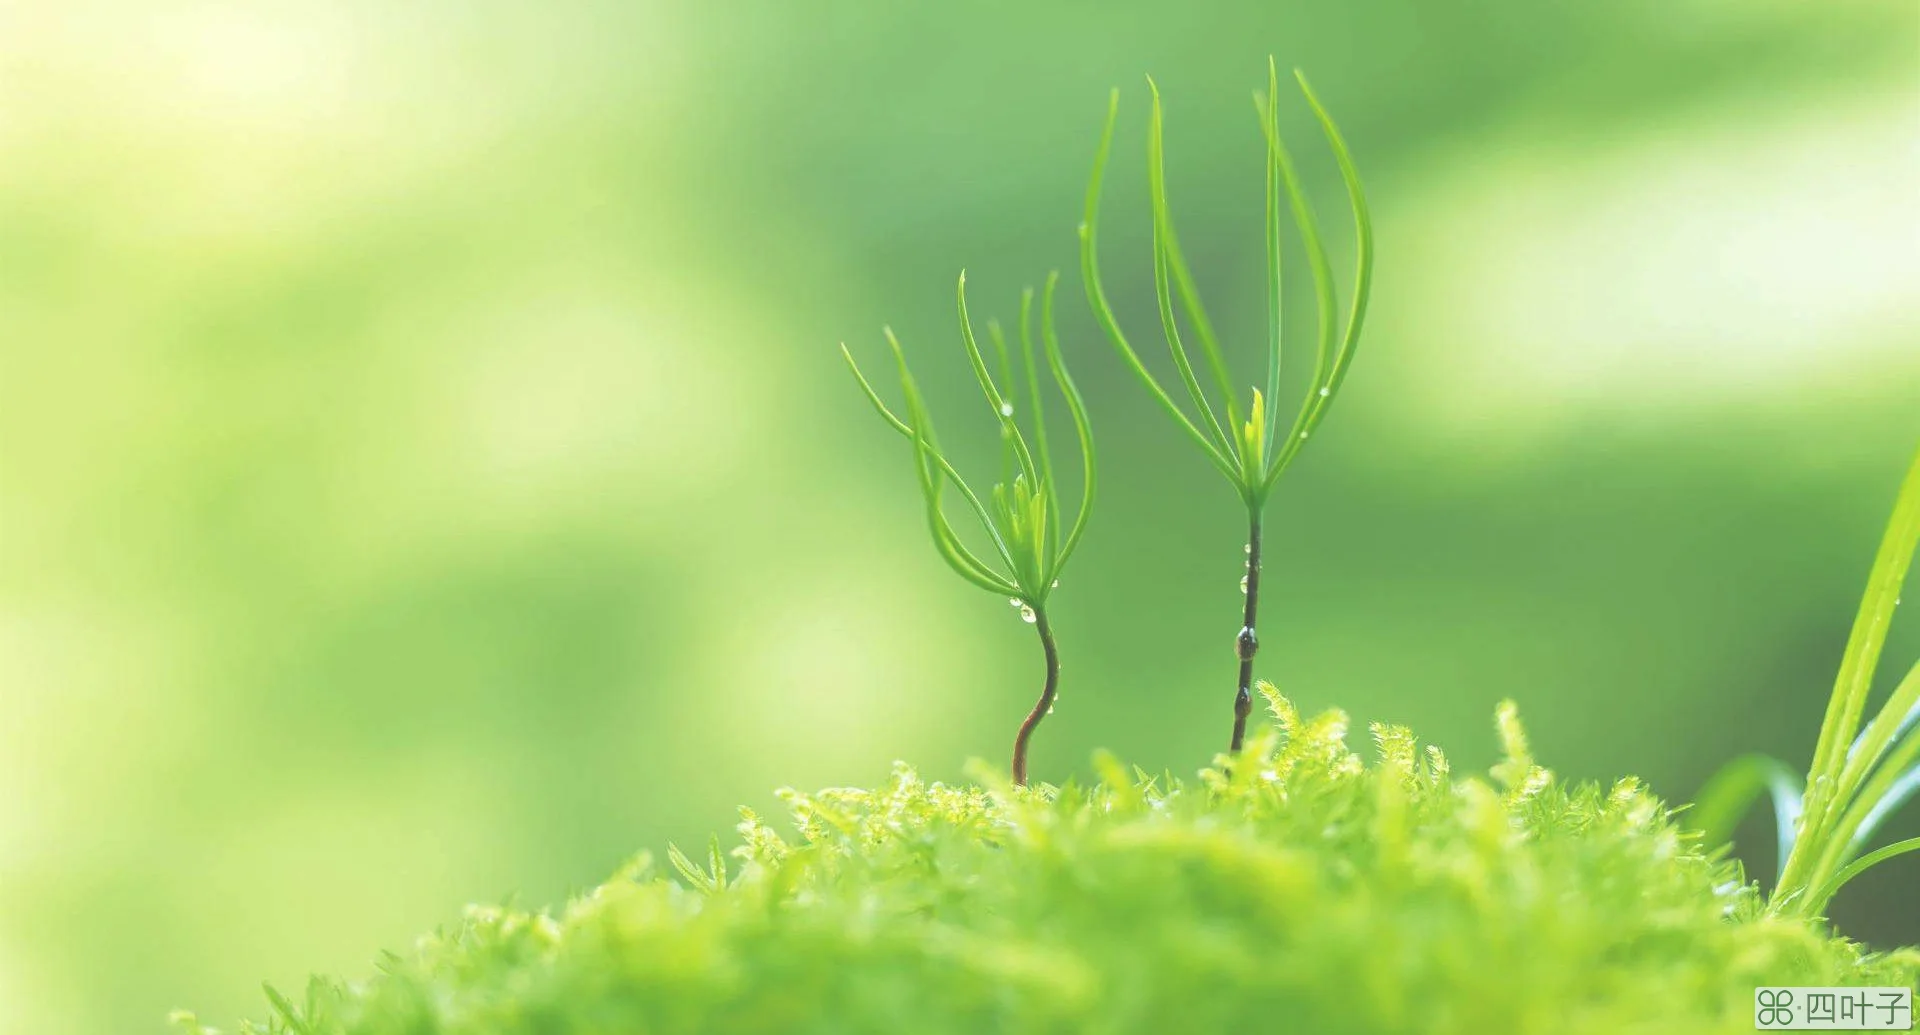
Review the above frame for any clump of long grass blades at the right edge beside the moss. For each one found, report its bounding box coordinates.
[1692,441,1920,918]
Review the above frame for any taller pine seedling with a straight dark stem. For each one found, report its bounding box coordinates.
[1081,58,1373,753]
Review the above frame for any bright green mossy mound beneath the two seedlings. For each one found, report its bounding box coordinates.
[177,687,1920,1035]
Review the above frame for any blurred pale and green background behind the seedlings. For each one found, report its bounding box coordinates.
[0,0,1920,1033]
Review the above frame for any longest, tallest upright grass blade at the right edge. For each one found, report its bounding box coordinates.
[1807,443,1920,867]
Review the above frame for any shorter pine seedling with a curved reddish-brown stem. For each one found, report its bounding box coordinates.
[841,271,1094,785]
